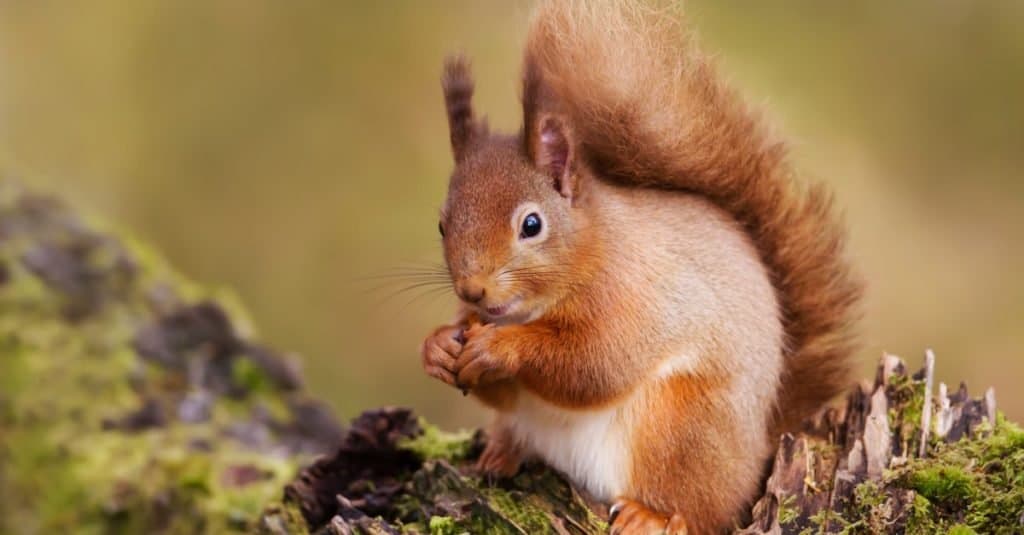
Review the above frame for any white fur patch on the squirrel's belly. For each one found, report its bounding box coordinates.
[502,392,630,501]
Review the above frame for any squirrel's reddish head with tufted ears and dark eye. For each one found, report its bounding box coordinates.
[438,57,589,323]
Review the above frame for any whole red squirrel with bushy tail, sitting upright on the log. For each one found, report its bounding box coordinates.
[421,0,862,534]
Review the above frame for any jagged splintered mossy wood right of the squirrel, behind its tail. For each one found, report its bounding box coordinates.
[743,352,1024,534]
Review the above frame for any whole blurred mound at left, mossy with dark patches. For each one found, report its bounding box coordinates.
[0,182,340,533]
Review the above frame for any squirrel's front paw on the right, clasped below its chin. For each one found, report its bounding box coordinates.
[454,324,519,390]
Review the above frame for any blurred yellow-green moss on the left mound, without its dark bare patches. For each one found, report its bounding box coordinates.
[0,189,315,534]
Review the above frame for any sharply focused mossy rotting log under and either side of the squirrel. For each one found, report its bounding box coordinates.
[267,354,1024,535]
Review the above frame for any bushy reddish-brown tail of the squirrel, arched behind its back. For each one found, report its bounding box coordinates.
[522,0,862,433]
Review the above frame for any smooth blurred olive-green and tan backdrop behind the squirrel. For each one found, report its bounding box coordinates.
[0,0,1024,426]
